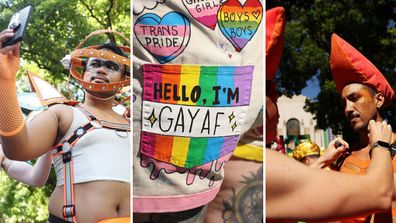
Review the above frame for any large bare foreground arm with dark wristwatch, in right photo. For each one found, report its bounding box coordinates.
[266,121,393,220]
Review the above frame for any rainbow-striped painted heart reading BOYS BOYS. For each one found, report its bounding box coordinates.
[217,0,263,52]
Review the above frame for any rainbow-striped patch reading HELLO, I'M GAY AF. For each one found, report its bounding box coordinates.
[140,64,253,168]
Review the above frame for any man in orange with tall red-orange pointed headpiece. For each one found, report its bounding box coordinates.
[330,34,396,222]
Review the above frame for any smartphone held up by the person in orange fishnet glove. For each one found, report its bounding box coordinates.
[2,5,32,47]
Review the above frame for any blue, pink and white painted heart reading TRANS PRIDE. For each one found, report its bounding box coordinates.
[134,12,191,64]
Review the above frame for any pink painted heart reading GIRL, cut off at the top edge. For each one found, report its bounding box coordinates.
[183,0,221,30]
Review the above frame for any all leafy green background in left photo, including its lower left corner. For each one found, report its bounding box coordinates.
[0,0,130,223]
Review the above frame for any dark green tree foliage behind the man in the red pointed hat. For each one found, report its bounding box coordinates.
[267,0,396,143]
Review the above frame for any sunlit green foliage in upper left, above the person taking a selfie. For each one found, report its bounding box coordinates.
[0,0,130,88]
